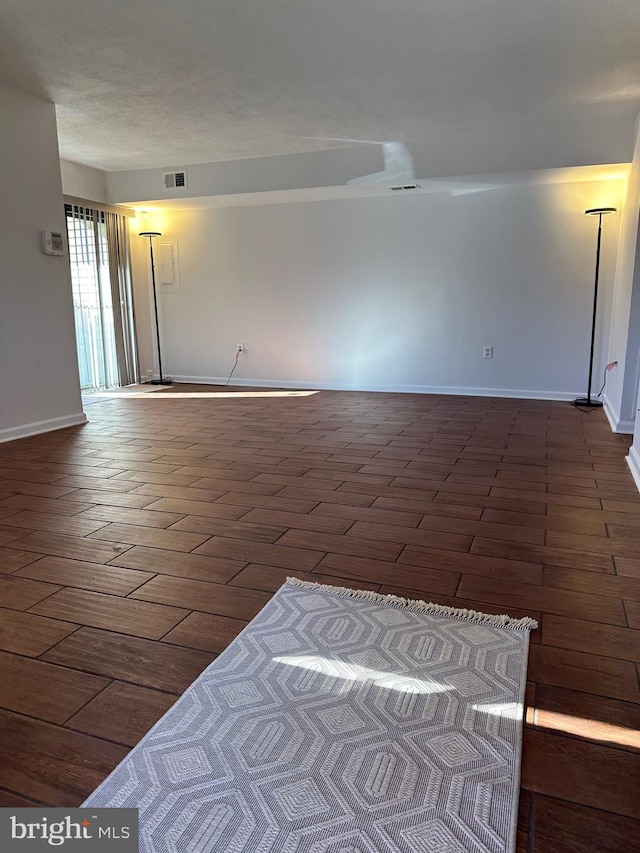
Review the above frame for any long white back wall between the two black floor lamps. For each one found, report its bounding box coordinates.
[133,173,624,399]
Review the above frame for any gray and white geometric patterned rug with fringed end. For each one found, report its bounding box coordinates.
[84,579,537,853]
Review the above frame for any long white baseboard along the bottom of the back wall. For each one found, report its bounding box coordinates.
[171,373,580,402]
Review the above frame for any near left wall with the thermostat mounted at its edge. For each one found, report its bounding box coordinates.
[0,85,85,441]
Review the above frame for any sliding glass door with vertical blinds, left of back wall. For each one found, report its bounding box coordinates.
[65,204,138,391]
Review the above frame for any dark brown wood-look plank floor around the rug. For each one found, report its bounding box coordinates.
[0,389,640,853]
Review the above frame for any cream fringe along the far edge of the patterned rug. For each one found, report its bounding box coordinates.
[287,577,538,631]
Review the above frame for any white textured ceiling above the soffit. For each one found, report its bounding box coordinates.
[0,0,640,170]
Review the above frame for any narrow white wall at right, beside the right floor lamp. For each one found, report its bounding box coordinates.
[605,115,640,433]
